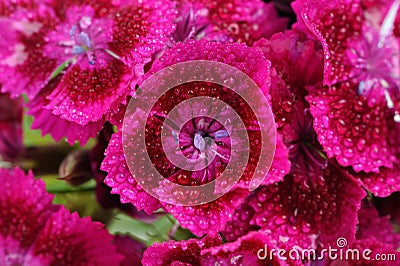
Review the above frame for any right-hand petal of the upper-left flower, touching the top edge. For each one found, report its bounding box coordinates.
[110,0,176,71]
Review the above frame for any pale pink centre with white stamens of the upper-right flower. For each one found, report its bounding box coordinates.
[347,0,400,122]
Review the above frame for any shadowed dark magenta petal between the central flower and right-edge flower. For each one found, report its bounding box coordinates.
[254,31,323,139]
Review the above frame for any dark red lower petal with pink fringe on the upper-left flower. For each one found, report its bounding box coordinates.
[46,53,131,125]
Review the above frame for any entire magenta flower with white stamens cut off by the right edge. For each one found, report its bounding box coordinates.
[300,1,400,196]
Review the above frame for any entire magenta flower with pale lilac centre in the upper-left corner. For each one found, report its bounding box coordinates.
[0,0,175,143]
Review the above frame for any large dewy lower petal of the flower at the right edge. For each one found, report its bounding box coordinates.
[307,82,397,173]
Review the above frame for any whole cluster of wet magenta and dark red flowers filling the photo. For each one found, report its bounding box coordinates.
[0,0,400,265]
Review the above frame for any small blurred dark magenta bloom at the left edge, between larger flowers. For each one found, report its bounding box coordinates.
[0,94,24,162]
